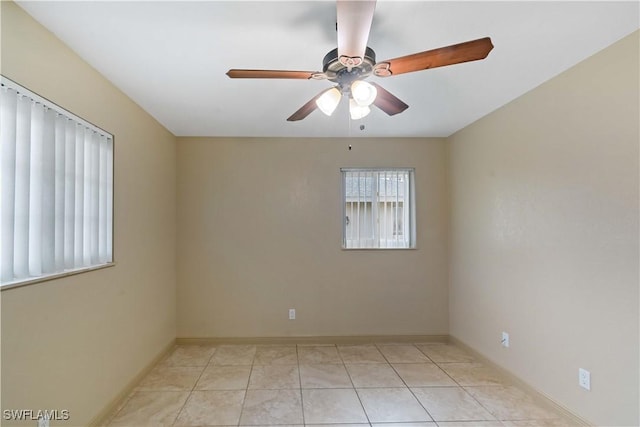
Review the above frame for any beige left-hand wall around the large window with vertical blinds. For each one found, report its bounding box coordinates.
[1,1,176,426]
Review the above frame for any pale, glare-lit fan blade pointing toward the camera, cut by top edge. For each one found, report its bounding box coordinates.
[336,0,376,68]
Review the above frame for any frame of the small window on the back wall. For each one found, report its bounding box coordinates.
[340,167,418,251]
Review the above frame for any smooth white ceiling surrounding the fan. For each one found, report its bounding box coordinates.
[18,0,640,137]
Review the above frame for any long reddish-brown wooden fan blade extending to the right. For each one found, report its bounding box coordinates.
[373,37,493,77]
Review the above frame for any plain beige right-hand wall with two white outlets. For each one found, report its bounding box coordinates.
[449,32,640,426]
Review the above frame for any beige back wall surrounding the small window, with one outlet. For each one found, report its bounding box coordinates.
[172,138,448,338]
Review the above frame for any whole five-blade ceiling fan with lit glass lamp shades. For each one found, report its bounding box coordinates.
[227,0,493,121]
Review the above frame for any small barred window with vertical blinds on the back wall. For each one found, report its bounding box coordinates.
[342,169,415,249]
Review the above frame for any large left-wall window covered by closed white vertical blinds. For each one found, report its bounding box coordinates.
[0,77,113,287]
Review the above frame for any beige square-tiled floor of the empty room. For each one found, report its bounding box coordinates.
[108,343,570,427]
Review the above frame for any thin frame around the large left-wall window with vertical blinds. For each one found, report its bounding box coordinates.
[0,75,116,292]
